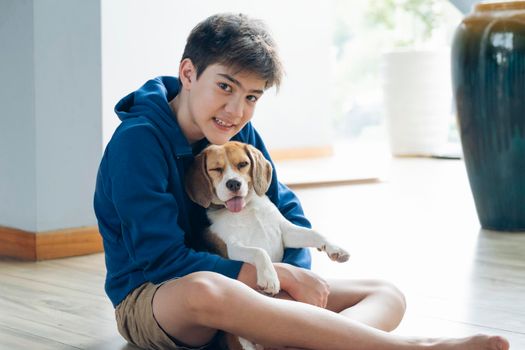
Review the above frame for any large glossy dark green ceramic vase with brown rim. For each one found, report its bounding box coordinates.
[452,1,525,231]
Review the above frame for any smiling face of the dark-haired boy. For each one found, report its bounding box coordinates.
[181,61,266,145]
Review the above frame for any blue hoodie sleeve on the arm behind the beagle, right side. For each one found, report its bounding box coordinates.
[236,123,312,269]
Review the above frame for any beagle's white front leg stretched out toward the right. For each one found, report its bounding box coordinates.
[280,217,350,262]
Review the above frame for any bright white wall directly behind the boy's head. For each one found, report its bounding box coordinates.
[102,0,332,149]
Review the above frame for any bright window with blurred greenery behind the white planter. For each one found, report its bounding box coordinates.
[332,0,462,157]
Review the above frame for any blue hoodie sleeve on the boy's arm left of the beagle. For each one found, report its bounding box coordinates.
[107,126,246,283]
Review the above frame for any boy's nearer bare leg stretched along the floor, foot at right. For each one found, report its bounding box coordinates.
[153,272,509,350]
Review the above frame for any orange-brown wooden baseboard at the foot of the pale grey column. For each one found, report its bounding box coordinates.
[0,226,104,261]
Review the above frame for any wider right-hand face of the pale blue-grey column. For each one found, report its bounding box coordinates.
[34,0,102,231]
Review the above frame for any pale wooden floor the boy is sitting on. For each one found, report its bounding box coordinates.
[0,159,525,350]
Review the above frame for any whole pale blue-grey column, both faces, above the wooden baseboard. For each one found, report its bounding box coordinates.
[0,0,102,232]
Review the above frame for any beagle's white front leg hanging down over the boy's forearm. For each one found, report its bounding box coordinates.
[227,242,281,295]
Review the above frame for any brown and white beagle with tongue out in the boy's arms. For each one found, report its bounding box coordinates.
[185,141,349,350]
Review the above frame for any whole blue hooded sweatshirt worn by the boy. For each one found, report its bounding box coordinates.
[94,77,311,306]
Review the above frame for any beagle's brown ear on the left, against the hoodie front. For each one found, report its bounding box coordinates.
[184,152,213,208]
